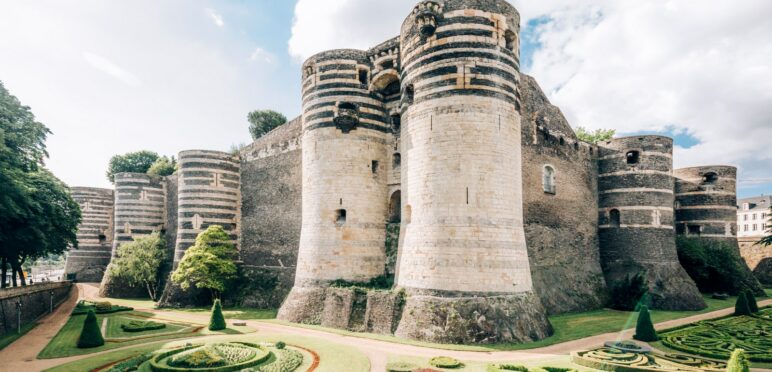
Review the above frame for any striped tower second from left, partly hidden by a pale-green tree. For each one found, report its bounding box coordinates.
[99,173,166,297]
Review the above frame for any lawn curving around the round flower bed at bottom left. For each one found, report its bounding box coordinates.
[46,333,370,372]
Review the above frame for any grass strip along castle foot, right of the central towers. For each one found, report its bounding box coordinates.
[269,290,772,351]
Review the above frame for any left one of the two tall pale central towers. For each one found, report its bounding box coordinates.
[278,50,395,322]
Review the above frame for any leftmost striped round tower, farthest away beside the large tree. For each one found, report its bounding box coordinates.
[64,187,114,283]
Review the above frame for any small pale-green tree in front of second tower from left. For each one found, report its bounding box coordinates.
[109,232,169,301]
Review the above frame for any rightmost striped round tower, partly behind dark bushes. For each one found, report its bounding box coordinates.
[673,165,764,295]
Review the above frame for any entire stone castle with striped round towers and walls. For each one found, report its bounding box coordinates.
[67,0,764,342]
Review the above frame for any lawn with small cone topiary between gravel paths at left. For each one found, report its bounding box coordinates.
[38,311,254,359]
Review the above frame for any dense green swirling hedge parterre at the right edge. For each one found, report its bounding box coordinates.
[661,308,772,362]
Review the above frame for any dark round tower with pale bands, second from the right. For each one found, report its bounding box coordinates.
[598,136,705,310]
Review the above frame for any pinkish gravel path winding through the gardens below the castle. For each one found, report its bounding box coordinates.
[0,284,772,372]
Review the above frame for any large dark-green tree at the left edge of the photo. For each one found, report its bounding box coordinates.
[0,83,81,287]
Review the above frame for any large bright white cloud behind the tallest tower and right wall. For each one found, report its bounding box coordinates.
[289,0,772,190]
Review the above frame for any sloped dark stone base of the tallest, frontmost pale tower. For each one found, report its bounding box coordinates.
[395,292,552,344]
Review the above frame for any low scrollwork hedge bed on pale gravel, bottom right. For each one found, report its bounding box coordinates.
[571,347,726,371]
